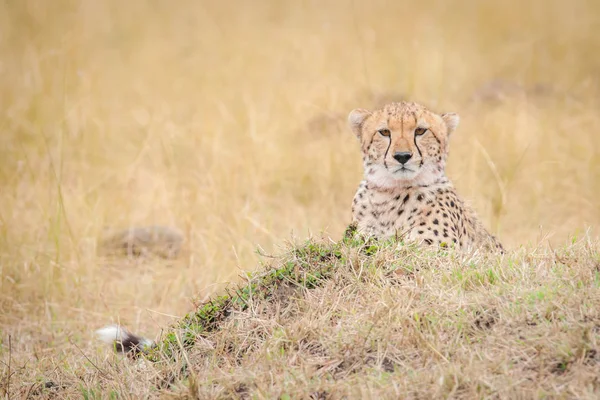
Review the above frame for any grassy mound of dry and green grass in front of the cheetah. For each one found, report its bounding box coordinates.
[105,239,600,399]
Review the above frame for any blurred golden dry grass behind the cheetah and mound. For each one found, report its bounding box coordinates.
[0,0,600,376]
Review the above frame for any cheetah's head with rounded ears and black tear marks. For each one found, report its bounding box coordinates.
[348,102,459,187]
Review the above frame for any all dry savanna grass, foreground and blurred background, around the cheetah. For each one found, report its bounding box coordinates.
[0,0,600,398]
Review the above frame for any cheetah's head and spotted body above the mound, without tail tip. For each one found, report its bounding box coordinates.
[348,102,503,252]
